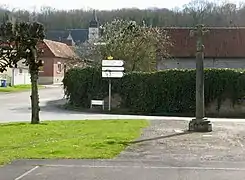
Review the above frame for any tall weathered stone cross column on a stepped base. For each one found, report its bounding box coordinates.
[189,24,212,132]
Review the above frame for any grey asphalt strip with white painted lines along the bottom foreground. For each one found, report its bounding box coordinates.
[0,160,245,180]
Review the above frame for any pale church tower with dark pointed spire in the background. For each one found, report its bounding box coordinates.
[88,10,99,42]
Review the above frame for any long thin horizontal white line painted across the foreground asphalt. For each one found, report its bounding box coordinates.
[44,164,245,171]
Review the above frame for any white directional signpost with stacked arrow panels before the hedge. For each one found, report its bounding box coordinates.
[102,57,124,111]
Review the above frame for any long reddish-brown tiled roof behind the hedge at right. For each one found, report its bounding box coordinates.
[164,27,245,58]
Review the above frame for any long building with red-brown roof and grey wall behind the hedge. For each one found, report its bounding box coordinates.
[157,27,245,70]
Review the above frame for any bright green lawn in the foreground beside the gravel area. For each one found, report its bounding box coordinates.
[0,120,148,165]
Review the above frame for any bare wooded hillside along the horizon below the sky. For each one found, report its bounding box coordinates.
[0,0,245,30]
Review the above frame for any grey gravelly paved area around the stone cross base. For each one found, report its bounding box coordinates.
[118,120,245,162]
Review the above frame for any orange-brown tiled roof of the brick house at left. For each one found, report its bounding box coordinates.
[44,39,77,59]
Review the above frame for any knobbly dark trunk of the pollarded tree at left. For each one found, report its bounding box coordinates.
[30,70,40,124]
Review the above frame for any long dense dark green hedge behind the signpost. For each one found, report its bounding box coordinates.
[63,67,245,114]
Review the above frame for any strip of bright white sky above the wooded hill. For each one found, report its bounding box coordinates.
[0,0,245,10]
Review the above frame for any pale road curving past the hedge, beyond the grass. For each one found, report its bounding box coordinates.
[0,86,245,123]
